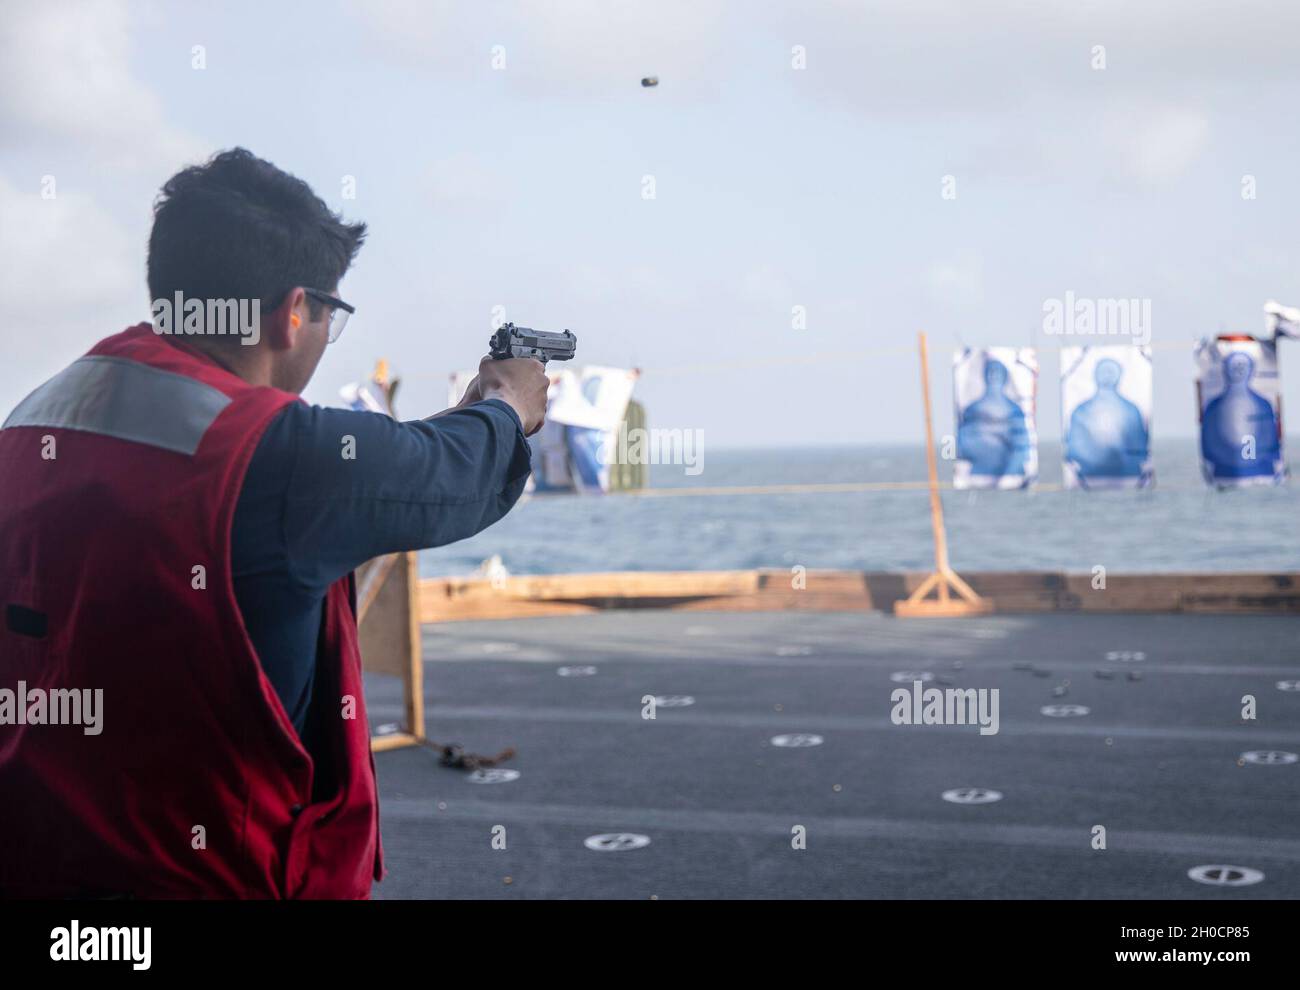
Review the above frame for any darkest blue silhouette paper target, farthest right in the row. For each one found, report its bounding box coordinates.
[1196,338,1287,489]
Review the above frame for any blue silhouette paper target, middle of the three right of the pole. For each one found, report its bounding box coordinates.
[1061,347,1154,490]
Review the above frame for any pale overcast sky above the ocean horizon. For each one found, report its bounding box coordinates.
[0,0,1300,447]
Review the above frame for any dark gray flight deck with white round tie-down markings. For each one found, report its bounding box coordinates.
[368,611,1300,899]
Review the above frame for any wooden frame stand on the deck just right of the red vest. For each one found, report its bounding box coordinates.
[356,552,424,752]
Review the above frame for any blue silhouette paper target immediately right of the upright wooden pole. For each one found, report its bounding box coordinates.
[953,347,1039,489]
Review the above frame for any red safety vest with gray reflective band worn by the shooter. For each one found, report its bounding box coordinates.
[0,324,384,898]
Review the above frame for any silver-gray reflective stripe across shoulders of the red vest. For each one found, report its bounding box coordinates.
[0,356,230,456]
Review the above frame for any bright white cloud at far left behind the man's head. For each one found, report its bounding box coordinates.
[0,0,200,414]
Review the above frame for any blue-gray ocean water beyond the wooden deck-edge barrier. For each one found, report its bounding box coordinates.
[420,438,1300,577]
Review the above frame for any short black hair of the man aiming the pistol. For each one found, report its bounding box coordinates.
[148,148,365,320]
